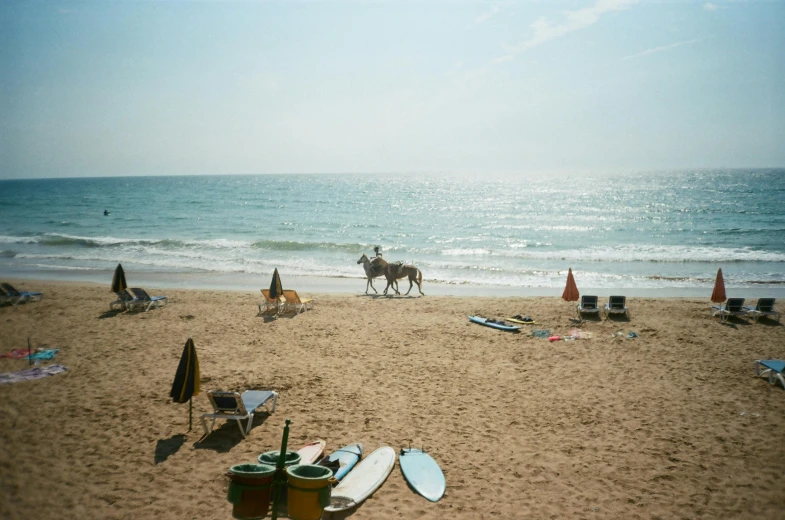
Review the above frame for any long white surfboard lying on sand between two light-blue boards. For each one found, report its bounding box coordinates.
[324,446,395,513]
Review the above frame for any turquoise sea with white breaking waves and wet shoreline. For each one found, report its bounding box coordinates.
[0,169,785,297]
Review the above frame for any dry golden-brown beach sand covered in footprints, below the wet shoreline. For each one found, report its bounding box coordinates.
[0,281,785,520]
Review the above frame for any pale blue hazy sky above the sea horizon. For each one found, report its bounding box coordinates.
[0,0,785,179]
